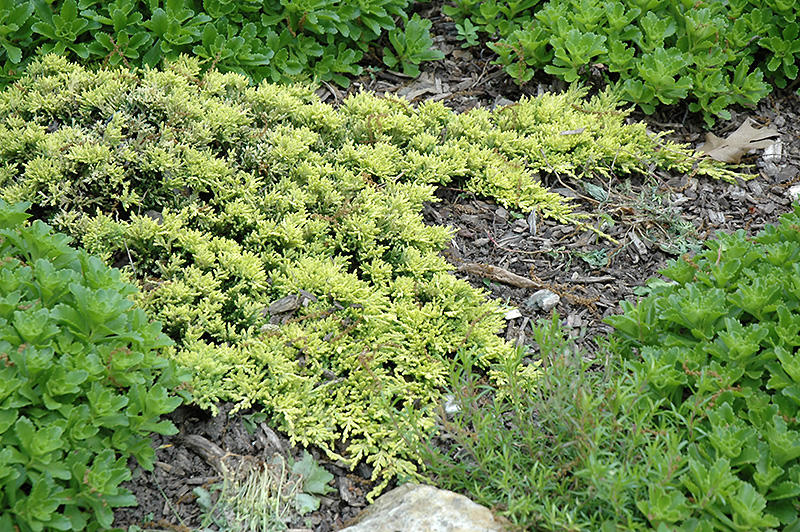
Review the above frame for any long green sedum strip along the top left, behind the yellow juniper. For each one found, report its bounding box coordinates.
[0,0,442,87]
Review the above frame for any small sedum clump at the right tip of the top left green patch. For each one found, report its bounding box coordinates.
[383,13,444,77]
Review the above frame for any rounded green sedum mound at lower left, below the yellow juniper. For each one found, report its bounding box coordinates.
[0,200,187,532]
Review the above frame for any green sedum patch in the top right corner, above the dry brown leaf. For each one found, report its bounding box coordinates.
[444,0,800,126]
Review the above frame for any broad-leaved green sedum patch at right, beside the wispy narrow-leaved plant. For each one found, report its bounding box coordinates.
[609,206,800,530]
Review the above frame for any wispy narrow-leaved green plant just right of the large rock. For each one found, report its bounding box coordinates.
[404,316,682,531]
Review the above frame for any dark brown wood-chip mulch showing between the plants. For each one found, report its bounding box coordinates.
[115,2,800,532]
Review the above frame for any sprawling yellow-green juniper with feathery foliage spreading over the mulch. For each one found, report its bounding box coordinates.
[0,56,736,494]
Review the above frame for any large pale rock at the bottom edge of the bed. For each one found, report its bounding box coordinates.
[340,484,508,532]
